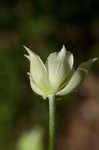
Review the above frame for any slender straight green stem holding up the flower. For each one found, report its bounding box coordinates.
[49,95,55,150]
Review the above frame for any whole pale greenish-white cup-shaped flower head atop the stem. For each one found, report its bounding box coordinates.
[24,45,97,99]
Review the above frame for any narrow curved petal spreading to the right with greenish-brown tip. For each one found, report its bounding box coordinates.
[56,58,97,95]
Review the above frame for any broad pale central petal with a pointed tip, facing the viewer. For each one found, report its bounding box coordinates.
[46,45,73,89]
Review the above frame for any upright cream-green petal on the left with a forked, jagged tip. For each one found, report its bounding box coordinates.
[24,46,49,90]
